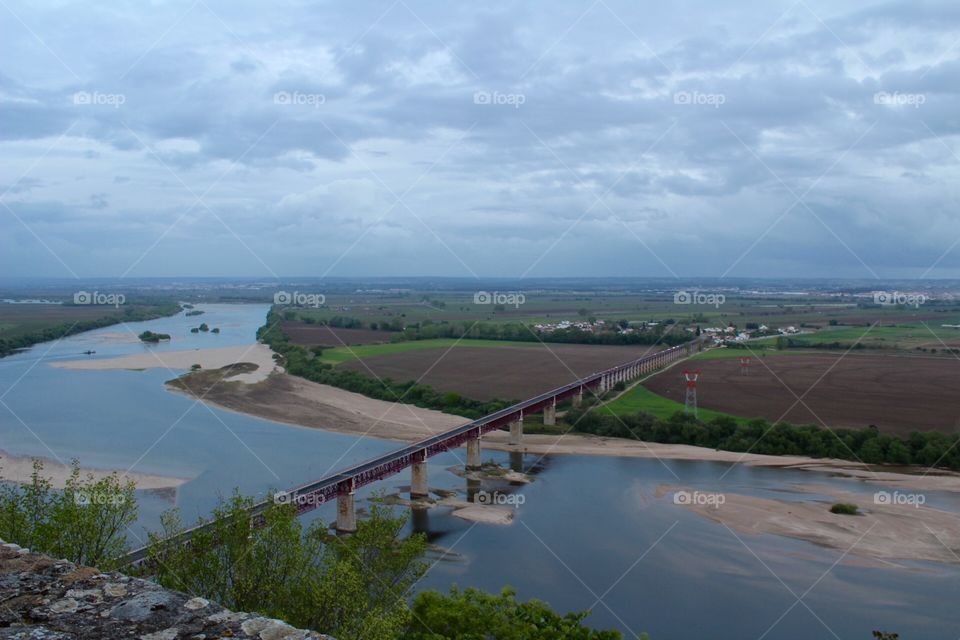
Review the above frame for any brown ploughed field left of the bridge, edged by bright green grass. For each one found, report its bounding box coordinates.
[339,343,663,400]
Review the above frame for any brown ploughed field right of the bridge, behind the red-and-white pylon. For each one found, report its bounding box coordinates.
[645,353,960,435]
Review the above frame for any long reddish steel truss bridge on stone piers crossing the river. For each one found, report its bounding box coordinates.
[120,341,697,566]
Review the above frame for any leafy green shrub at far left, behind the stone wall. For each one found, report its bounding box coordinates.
[0,460,137,570]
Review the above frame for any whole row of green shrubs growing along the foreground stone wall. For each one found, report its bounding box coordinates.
[0,462,620,640]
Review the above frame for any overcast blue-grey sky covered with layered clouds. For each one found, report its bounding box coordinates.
[0,0,960,278]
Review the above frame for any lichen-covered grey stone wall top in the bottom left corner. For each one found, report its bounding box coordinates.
[0,541,333,640]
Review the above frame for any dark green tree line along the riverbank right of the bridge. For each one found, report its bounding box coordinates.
[565,403,960,470]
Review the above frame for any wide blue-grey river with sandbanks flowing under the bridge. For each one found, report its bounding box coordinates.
[0,305,960,640]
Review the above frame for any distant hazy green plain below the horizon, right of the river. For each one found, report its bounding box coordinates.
[280,283,960,337]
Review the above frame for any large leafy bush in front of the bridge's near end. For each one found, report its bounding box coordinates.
[150,494,426,640]
